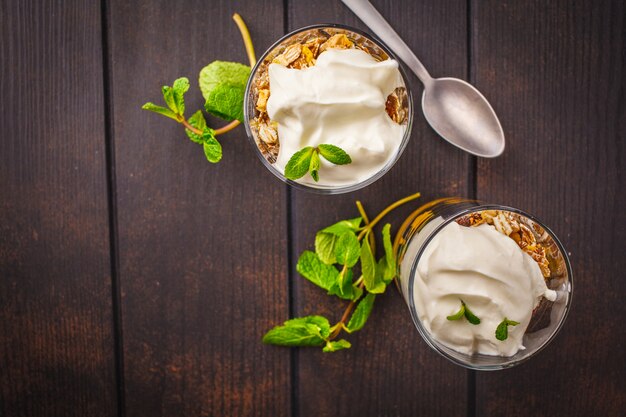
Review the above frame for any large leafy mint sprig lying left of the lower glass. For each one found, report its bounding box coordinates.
[263,193,420,352]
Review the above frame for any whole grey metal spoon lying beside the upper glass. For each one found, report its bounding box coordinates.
[341,0,504,158]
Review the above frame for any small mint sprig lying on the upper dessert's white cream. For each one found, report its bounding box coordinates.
[285,144,352,182]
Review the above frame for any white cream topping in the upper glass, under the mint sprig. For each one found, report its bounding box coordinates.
[267,49,406,186]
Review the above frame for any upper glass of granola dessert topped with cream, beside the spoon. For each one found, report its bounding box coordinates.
[244,24,413,194]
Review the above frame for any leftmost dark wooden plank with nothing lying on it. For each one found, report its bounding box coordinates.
[0,1,117,417]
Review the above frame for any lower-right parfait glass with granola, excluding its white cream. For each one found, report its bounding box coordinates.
[394,198,573,370]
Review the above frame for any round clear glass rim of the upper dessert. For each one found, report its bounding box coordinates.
[243,23,414,195]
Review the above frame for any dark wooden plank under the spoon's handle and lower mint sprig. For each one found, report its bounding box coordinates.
[288,0,470,416]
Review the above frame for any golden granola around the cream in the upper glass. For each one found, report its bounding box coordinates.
[250,28,408,163]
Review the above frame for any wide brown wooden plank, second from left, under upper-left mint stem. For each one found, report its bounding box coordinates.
[111,1,290,416]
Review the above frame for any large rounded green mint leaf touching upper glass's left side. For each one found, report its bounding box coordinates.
[198,61,250,123]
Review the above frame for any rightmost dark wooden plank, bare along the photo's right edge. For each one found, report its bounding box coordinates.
[473,1,626,416]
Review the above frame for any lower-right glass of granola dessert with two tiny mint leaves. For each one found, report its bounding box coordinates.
[395,198,572,370]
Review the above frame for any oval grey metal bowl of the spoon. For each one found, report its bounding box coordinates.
[422,78,504,158]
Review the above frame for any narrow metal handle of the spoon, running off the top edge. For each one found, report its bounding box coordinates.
[341,0,432,84]
